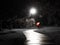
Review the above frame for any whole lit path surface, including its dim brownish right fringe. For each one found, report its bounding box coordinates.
[24,29,54,45]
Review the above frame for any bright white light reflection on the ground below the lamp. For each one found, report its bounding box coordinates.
[24,29,46,45]
